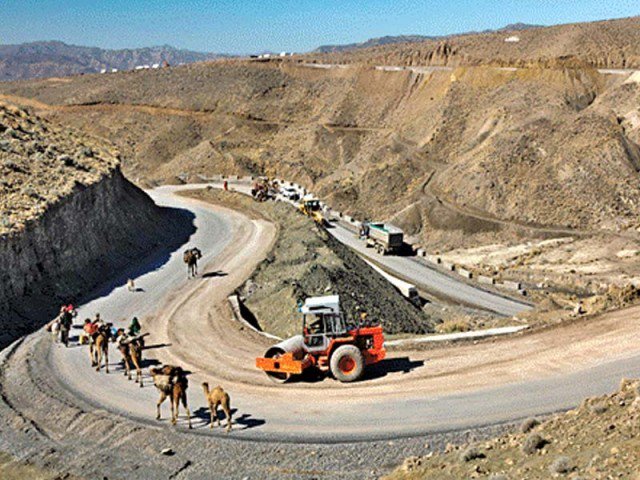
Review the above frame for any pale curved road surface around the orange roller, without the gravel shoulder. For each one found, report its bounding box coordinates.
[1,187,640,443]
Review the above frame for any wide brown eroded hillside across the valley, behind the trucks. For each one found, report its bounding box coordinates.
[0,57,640,251]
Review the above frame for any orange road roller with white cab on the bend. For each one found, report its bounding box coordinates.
[256,295,386,383]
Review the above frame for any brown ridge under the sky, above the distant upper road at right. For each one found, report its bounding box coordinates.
[307,17,640,68]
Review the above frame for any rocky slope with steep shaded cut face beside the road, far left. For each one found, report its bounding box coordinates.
[0,106,191,348]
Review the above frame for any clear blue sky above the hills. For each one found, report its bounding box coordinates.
[0,0,640,54]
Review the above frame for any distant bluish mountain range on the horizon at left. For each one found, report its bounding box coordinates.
[0,41,230,81]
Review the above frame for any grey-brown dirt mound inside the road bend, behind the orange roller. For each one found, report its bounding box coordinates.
[184,189,434,337]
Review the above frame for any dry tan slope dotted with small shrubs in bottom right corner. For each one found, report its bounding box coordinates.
[385,381,640,480]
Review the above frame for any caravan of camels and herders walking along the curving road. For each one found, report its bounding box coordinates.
[47,248,232,433]
